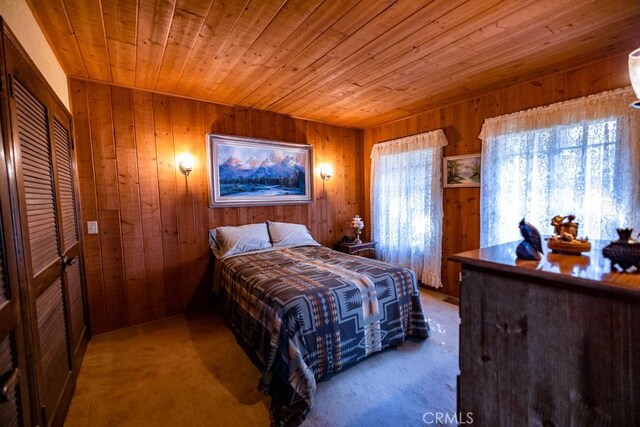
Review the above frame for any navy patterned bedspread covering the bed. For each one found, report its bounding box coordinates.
[220,246,429,425]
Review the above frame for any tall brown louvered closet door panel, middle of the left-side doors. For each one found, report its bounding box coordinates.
[12,79,71,424]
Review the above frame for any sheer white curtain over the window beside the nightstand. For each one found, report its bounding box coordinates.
[371,130,447,287]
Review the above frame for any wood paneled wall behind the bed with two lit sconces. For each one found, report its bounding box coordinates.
[70,79,364,333]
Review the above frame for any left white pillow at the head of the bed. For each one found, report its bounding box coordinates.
[209,222,271,258]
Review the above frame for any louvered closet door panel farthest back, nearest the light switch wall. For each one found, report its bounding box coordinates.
[53,118,86,354]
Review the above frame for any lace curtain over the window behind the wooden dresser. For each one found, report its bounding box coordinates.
[480,88,640,247]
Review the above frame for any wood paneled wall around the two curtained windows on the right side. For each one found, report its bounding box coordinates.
[364,55,630,296]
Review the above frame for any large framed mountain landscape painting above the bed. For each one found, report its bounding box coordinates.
[207,134,313,207]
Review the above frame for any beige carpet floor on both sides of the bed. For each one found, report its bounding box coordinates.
[65,291,459,427]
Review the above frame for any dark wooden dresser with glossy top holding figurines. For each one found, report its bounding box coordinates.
[450,242,640,427]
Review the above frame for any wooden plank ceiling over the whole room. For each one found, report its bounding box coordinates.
[27,0,640,127]
